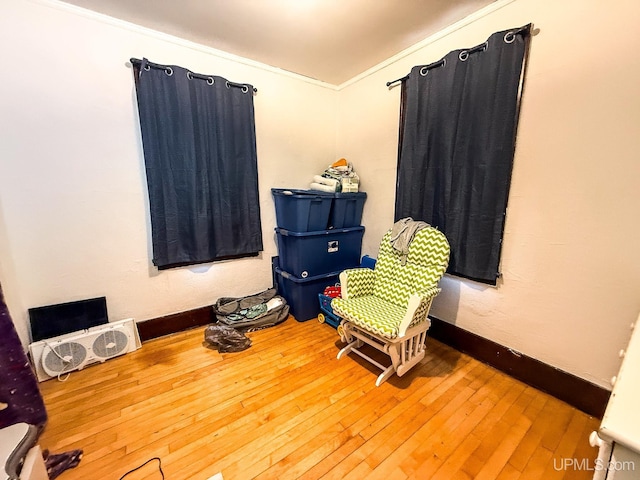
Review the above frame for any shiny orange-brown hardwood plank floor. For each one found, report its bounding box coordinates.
[40,318,599,480]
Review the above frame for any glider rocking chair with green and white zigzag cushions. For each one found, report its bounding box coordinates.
[331,226,449,386]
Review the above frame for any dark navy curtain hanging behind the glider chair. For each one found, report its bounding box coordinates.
[395,25,531,285]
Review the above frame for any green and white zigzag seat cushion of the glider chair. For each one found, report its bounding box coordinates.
[331,295,406,339]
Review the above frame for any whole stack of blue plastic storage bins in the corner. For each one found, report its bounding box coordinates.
[271,188,367,322]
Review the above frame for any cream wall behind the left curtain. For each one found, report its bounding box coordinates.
[0,0,337,343]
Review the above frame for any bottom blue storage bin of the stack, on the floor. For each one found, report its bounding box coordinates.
[274,267,340,322]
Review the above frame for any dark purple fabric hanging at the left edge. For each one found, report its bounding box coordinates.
[0,286,47,428]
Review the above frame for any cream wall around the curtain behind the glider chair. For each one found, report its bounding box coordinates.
[337,0,640,388]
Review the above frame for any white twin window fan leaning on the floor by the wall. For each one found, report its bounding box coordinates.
[29,318,141,382]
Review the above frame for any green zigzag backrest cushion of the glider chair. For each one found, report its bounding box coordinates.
[373,226,449,307]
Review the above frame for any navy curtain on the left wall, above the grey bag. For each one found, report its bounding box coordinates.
[131,59,262,268]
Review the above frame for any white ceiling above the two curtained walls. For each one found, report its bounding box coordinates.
[65,0,494,85]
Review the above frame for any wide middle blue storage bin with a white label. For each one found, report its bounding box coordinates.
[276,227,364,278]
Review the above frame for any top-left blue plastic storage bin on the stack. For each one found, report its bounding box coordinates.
[271,188,333,232]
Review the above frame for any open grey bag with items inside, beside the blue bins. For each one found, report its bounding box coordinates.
[213,288,289,332]
